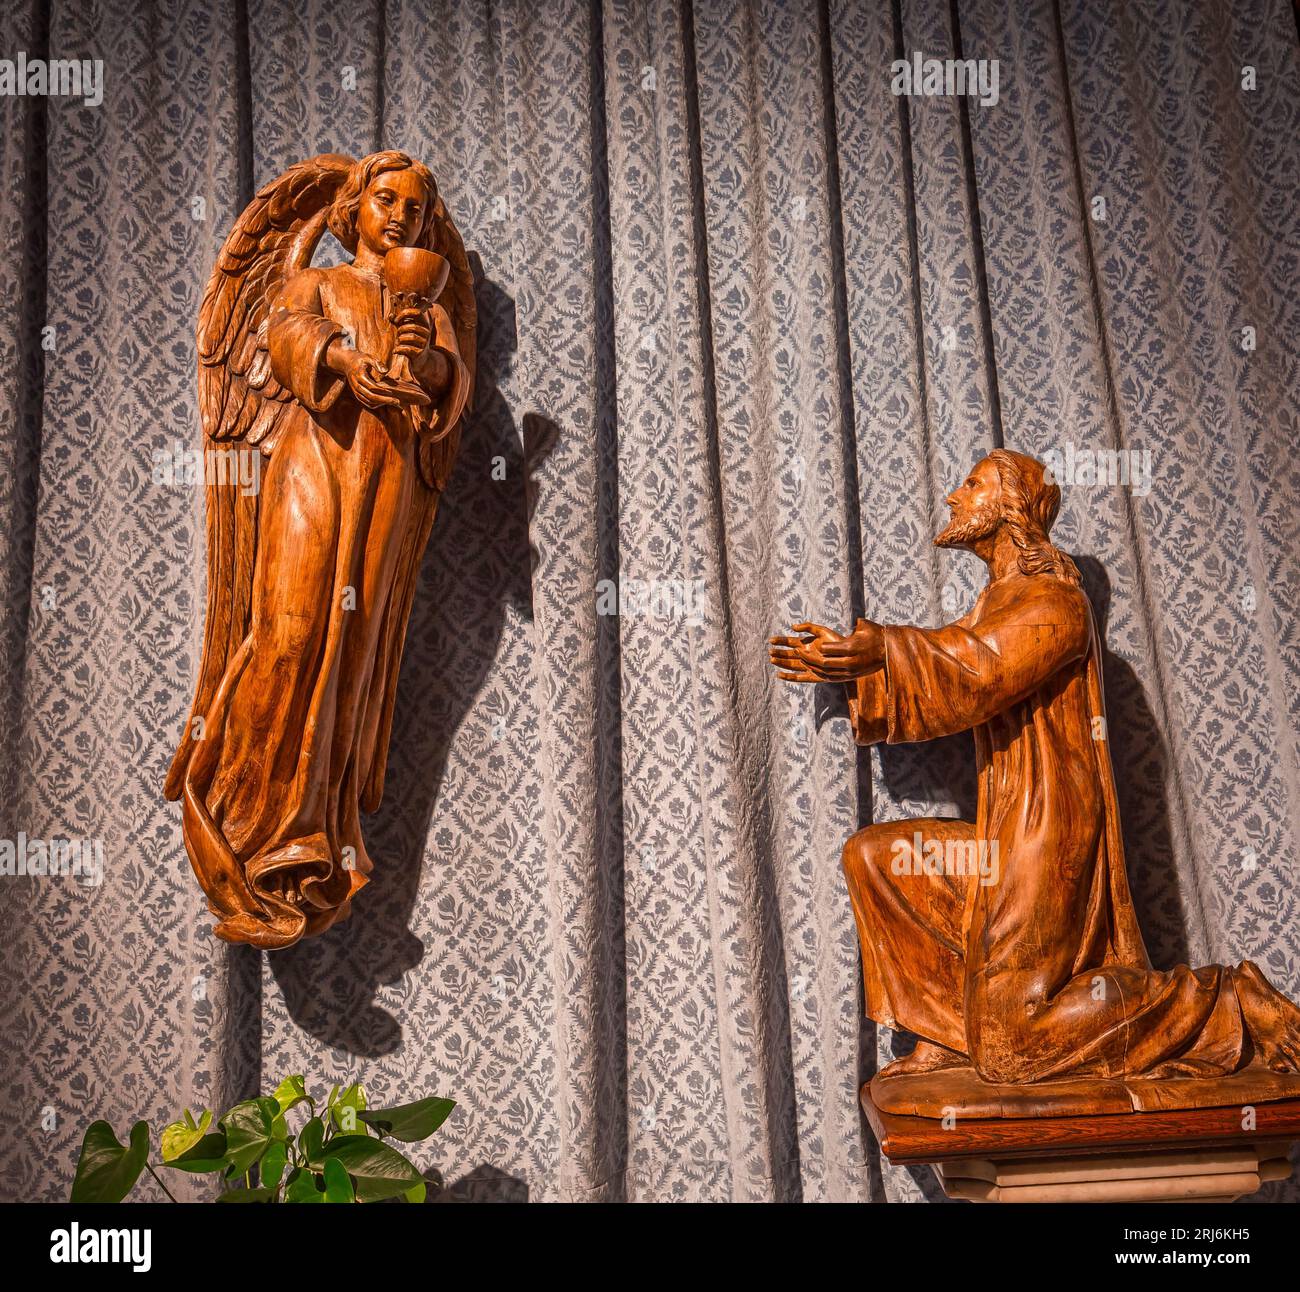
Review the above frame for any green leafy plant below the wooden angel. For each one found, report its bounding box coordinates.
[72,1076,456,1202]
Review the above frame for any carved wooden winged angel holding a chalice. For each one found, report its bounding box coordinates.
[165,152,476,949]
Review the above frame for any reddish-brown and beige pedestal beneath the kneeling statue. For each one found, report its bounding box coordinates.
[862,1084,1300,1202]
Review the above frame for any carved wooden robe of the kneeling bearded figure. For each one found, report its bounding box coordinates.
[844,573,1300,1083]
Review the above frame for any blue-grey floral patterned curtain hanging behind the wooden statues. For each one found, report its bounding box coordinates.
[0,0,1300,1200]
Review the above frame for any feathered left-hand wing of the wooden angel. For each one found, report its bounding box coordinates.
[164,153,353,798]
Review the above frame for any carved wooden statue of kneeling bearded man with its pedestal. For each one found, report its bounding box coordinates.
[770,450,1300,1198]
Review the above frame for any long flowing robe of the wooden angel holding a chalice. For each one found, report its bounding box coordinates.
[169,265,468,948]
